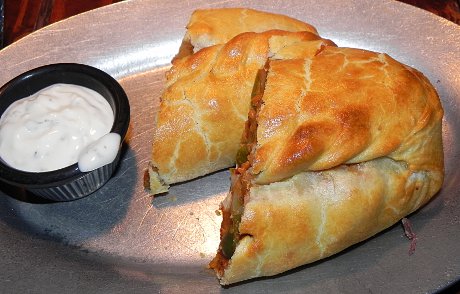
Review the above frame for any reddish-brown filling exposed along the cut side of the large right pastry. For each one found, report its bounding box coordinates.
[210,66,267,275]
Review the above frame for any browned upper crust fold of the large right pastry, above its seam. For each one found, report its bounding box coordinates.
[252,47,443,184]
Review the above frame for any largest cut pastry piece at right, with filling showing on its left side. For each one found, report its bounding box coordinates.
[210,47,444,285]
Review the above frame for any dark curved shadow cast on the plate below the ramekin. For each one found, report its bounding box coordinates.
[0,146,138,245]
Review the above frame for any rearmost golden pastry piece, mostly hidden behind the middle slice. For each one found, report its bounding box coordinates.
[177,8,318,57]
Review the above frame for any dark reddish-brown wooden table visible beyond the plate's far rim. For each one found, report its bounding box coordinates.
[0,0,460,47]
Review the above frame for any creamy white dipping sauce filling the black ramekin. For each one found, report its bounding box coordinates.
[0,84,119,172]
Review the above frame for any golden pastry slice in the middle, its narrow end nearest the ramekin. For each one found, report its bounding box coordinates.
[149,30,333,194]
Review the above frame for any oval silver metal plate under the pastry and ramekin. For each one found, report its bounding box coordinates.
[0,0,460,293]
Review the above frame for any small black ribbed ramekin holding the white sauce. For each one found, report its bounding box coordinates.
[0,63,130,201]
